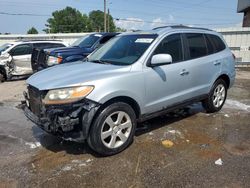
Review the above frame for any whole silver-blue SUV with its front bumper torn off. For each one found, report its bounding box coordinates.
[23,26,235,155]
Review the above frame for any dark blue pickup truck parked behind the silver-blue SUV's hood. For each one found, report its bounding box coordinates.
[32,33,118,72]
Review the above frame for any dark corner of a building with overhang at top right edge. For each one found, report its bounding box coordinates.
[237,0,250,27]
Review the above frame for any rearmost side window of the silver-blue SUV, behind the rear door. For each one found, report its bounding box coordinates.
[206,34,226,54]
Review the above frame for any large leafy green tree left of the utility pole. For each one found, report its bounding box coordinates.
[44,7,91,33]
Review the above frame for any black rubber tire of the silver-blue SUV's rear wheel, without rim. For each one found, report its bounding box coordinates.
[202,79,227,113]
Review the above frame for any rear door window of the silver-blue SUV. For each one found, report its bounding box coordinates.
[186,33,207,59]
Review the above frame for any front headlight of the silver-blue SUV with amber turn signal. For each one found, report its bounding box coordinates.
[43,86,94,105]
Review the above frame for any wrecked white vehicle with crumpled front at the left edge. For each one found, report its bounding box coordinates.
[0,40,65,81]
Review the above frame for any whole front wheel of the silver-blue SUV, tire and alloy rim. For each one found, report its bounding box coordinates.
[87,102,136,156]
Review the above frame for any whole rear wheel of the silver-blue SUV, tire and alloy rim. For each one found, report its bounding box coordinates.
[202,79,227,113]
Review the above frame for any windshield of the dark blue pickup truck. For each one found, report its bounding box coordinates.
[72,34,102,48]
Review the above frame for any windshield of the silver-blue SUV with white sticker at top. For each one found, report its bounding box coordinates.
[88,34,157,65]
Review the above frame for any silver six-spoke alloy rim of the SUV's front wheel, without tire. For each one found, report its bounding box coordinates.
[101,111,132,149]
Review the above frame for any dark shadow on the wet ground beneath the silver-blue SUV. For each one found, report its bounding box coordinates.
[32,103,204,157]
